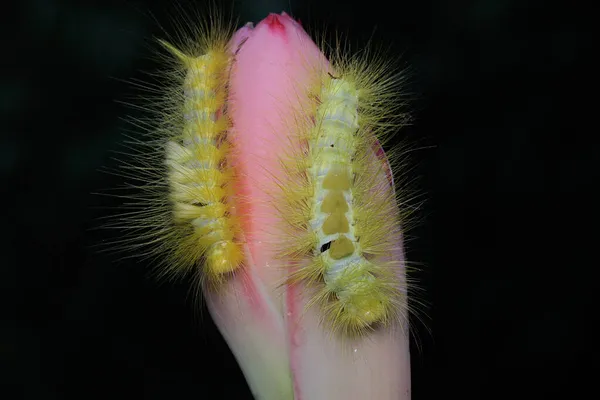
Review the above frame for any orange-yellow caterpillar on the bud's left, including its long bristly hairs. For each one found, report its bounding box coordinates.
[105,12,244,288]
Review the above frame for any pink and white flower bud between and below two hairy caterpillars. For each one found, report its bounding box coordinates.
[206,13,410,400]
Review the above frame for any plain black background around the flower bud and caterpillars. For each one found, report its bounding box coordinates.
[0,0,598,399]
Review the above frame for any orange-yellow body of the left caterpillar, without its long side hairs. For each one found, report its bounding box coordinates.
[162,42,243,280]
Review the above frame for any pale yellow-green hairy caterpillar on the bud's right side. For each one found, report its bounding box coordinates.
[277,41,418,337]
